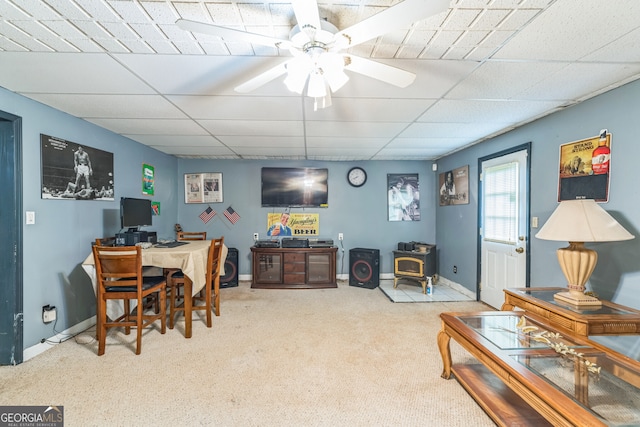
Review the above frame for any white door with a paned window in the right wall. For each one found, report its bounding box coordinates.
[480,150,529,309]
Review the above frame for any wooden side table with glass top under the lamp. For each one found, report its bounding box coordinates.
[501,288,640,336]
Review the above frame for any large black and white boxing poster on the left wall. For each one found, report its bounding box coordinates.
[40,134,114,200]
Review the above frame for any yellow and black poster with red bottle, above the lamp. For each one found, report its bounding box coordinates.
[558,129,611,202]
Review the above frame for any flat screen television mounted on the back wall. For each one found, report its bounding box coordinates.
[262,168,329,208]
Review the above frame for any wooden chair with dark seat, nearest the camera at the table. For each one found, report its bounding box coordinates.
[92,245,167,356]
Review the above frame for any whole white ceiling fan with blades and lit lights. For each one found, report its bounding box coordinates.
[176,0,450,108]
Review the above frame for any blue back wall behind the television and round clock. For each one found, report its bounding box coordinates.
[178,160,436,275]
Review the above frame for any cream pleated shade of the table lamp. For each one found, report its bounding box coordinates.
[536,199,635,242]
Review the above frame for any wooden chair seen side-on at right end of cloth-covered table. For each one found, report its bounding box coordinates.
[167,236,224,329]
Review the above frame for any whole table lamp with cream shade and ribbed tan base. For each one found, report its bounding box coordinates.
[536,199,635,306]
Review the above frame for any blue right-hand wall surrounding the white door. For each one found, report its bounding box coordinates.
[434,77,640,309]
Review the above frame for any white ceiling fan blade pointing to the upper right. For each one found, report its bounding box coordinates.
[335,0,451,49]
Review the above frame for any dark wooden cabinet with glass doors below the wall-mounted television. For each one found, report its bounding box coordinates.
[251,247,338,289]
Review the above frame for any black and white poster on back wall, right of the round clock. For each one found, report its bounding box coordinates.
[387,173,420,221]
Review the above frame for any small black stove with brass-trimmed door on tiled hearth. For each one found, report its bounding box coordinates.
[393,245,436,294]
